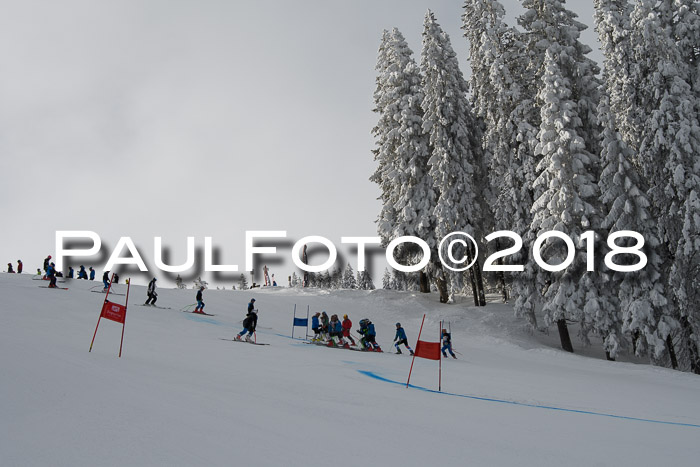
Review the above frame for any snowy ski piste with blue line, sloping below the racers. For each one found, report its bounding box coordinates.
[0,274,700,466]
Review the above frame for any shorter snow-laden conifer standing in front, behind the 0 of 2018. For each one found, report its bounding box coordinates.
[532,47,600,352]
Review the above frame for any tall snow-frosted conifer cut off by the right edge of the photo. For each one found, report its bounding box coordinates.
[629,0,700,373]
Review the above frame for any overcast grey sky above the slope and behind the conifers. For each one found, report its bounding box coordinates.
[0,0,598,284]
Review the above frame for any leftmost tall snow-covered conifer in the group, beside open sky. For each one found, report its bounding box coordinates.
[370,28,435,292]
